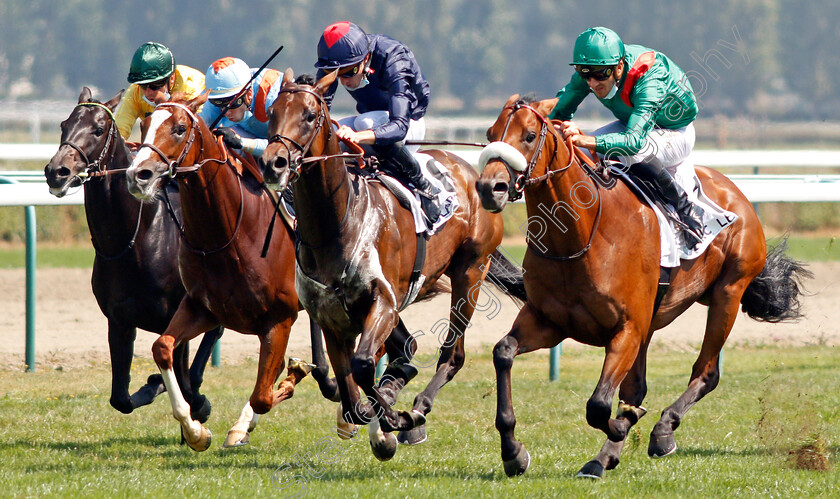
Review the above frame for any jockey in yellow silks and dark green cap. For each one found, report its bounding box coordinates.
[114,42,204,139]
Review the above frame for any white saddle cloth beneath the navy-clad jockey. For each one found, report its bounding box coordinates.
[380,153,459,236]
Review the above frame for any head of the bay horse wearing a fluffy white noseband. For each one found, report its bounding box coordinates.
[476,94,564,213]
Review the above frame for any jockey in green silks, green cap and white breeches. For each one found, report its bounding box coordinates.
[548,27,703,248]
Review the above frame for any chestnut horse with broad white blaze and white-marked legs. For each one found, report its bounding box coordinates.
[127,93,316,451]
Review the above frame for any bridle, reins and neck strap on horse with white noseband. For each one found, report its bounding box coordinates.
[492,102,603,261]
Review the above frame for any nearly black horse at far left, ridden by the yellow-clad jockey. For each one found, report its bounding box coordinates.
[44,87,222,422]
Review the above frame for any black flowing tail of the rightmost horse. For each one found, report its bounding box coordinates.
[741,237,814,322]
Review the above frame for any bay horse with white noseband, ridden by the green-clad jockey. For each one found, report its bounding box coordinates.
[477,95,809,477]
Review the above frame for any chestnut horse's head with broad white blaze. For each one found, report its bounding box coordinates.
[126,92,213,199]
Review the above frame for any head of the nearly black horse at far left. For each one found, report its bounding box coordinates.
[44,87,123,198]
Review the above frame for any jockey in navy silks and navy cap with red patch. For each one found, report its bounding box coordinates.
[315,21,440,222]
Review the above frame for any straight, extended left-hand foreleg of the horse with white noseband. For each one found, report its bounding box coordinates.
[493,304,563,476]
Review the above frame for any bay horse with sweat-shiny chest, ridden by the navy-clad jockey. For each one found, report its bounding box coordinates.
[262,69,524,460]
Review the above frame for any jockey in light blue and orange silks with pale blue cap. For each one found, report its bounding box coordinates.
[199,57,283,156]
